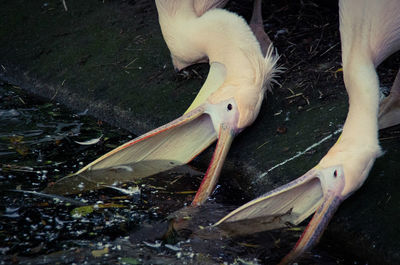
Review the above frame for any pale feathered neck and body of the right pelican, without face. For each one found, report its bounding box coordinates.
[319,0,400,196]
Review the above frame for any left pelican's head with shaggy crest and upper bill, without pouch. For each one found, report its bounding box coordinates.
[189,50,277,205]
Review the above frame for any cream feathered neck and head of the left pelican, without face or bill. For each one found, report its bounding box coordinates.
[156,0,277,128]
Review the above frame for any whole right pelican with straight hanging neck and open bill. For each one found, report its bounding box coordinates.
[216,0,400,264]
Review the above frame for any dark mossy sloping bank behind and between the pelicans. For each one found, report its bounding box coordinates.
[0,0,400,264]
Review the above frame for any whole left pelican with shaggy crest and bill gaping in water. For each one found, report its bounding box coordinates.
[75,0,278,206]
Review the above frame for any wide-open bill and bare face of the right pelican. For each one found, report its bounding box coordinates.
[215,166,345,264]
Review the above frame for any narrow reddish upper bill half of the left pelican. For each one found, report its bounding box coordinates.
[192,124,235,206]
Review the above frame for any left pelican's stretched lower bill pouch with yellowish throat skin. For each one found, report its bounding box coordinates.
[46,62,230,193]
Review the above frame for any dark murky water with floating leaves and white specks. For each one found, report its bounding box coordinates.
[0,83,362,264]
